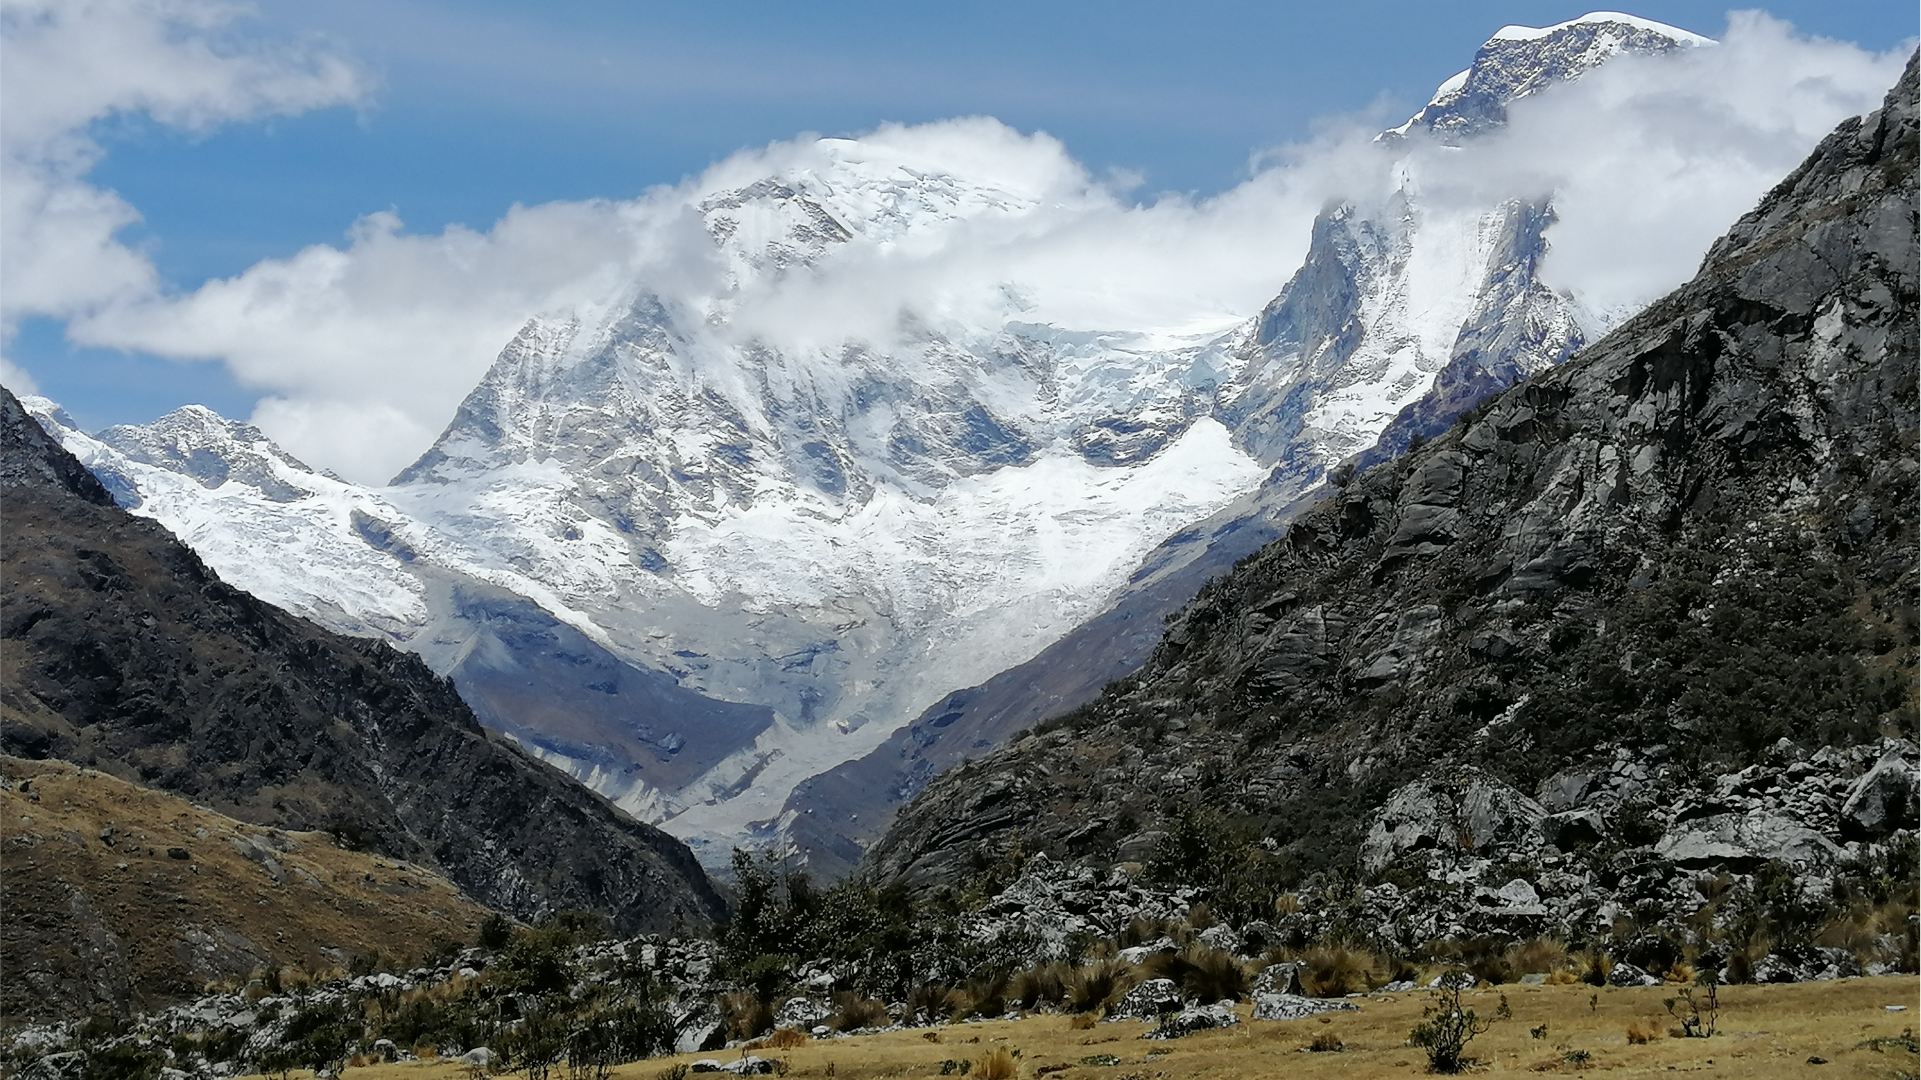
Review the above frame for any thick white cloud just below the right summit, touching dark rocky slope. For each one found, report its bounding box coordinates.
[1422,12,1911,317]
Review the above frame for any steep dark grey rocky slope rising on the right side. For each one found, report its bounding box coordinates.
[868,44,1921,884]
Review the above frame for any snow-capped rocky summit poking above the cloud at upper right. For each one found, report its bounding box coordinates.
[1385,12,1715,142]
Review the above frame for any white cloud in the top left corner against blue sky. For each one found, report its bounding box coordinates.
[0,0,365,357]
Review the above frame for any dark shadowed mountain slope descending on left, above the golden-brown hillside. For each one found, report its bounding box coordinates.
[0,382,724,928]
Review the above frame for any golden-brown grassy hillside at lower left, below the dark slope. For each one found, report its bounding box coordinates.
[0,757,486,1019]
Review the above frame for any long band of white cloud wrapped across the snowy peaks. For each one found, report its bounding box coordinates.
[56,15,1904,482]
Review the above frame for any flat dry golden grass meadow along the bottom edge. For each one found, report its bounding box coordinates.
[280,976,1921,1080]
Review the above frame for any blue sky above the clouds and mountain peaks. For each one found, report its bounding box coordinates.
[10,0,1921,438]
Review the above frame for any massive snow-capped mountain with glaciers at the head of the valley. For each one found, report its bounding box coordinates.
[29,15,1700,863]
